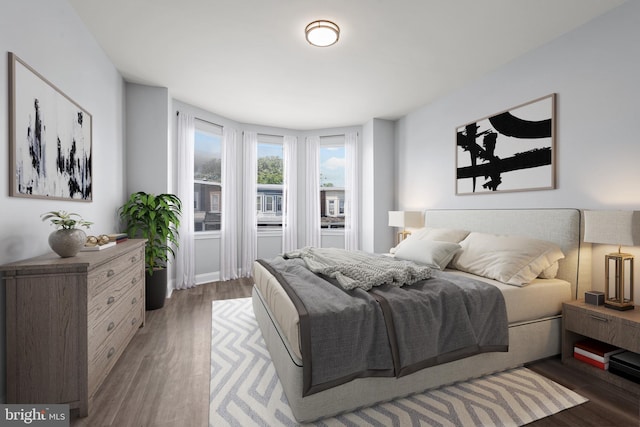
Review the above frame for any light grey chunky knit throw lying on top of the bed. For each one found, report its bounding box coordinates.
[284,247,431,291]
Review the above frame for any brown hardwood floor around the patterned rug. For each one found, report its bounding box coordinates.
[71,279,640,427]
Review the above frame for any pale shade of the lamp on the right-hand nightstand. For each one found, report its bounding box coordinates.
[584,211,640,246]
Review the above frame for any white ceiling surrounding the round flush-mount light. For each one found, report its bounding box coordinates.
[69,0,625,130]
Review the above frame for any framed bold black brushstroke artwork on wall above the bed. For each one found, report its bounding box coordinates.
[456,94,555,194]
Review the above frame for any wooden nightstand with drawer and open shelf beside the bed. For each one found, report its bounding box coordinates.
[562,299,640,396]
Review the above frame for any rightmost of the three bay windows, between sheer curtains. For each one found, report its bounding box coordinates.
[320,136,345,228]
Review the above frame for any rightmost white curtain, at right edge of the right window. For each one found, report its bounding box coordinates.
[344,132,360,251]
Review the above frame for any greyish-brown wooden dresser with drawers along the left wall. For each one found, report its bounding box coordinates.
[0,239,145,416]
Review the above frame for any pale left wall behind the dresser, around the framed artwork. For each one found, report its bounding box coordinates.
[0,0,124,402]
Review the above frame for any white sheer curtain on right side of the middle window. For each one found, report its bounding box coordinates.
[282,136,298,252]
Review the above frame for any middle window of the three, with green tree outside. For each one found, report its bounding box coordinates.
[256,134,284,230]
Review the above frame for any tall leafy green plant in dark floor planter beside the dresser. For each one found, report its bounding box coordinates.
[119,191,182,310]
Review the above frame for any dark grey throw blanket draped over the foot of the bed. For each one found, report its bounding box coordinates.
[258,257,509,396]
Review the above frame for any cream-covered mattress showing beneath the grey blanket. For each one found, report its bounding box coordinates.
[253,263,571,361]
